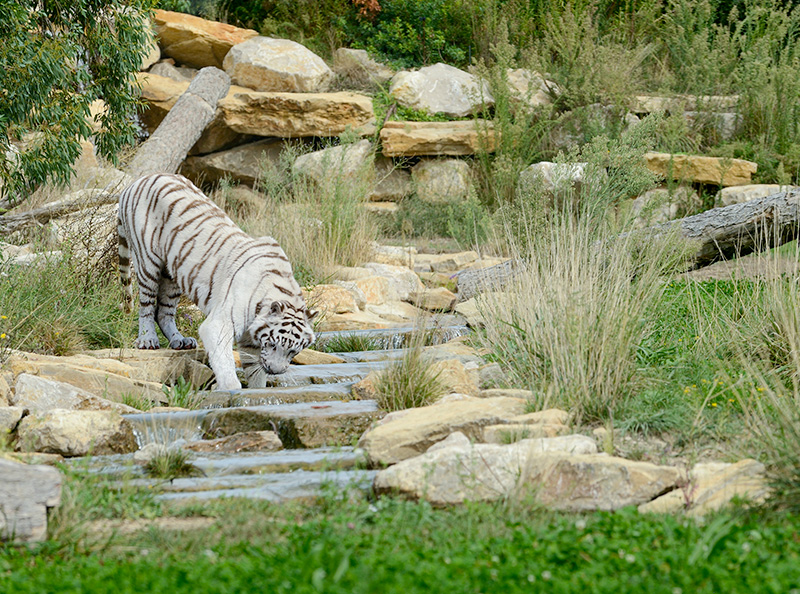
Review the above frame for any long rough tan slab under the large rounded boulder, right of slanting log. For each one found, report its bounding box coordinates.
[218,91,375,138]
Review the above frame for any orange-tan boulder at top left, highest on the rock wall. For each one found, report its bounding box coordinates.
[154,10,258,68]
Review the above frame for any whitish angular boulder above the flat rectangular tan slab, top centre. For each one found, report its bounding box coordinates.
[389,63,494,118]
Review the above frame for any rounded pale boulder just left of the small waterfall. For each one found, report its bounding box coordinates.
[16,409,138,457]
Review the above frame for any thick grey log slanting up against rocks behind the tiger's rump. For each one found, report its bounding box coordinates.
[127,66,231,179]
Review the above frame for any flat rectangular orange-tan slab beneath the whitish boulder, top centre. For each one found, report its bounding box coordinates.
[381,120,496,157]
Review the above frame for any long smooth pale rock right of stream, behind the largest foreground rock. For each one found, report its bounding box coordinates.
[358,398,526,466]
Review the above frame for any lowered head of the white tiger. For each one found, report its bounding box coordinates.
[250,301,317,374]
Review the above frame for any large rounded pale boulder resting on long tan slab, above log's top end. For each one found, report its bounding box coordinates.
[223,37,333,93]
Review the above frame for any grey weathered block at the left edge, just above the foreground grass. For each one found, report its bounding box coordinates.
[0,459,61,542]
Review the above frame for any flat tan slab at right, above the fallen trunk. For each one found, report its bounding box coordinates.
[644,153,758,186]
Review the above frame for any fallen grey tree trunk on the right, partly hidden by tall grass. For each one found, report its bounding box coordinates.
[456,190,800,301]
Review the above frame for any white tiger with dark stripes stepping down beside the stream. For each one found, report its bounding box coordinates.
[118,174,316,390]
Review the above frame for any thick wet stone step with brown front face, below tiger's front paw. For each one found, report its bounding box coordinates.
[202,400,383,448]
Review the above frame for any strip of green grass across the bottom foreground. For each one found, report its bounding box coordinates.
[0,484,800,594]
